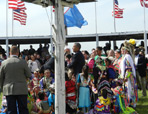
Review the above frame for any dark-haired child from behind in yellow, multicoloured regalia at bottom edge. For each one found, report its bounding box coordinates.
[94,89,111,114]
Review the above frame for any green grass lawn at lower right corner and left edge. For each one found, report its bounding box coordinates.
[0,90,148,114]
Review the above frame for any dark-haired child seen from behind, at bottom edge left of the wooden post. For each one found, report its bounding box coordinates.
[36,91,51,114]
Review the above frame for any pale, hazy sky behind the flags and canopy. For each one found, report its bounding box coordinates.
[0,0,148,51]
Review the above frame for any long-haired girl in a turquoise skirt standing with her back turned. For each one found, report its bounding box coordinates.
[77,65,90,113]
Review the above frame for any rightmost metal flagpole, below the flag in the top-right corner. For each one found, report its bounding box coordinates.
[143,0,147,55]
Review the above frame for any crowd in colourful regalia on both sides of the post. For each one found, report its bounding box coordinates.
[0,39,147,114]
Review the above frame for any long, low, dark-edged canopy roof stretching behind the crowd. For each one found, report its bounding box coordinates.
[0,32,144,44]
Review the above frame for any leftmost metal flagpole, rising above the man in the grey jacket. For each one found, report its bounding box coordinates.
[6,0,9,58]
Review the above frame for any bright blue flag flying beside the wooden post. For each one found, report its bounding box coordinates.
[64,5,88,28]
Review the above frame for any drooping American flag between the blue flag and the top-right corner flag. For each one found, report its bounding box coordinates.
[112,0,123,18]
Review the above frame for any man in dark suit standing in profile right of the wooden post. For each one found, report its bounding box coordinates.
[68,43,85,76]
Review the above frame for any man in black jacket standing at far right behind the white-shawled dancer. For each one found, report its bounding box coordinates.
[134,49,146,96]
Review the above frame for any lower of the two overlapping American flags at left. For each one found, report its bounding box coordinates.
[13,9,27,25]
